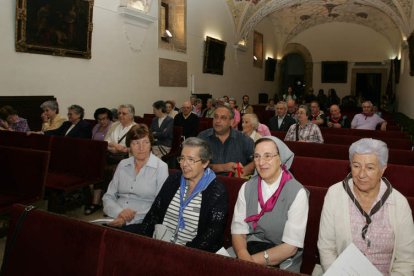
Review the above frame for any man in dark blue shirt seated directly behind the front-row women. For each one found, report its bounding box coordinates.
[198,106,254,177]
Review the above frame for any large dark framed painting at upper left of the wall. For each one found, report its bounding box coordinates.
[15,0,93,59]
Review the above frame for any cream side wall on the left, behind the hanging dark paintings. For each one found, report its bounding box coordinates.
[0,0,274,117]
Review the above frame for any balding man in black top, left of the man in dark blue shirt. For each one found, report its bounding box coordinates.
[174,101,199,138]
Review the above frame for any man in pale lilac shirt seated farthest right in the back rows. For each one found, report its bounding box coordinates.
[351,101,387,131]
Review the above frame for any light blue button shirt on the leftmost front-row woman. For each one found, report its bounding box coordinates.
[102,153,168,224]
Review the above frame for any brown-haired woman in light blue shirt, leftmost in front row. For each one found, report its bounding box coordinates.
[102,124,168,231]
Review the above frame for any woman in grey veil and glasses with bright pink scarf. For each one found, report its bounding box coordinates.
[231,136,309,272]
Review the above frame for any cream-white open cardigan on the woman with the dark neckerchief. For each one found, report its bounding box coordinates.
[318,179,414,276]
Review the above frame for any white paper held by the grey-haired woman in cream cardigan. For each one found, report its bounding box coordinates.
[324,243,382,276]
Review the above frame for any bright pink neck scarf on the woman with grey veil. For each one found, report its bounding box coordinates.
[244,166,292,230]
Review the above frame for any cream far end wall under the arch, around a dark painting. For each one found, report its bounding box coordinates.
[292,23,398,100]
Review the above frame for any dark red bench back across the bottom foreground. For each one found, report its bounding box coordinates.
[2,205,299,276]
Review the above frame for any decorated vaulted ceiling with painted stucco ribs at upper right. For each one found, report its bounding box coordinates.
[226,0,414,47]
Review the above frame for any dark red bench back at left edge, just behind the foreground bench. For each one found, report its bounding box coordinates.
[0,146,50,212]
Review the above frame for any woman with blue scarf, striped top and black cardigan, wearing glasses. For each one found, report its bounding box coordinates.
[135,137,227,252]
